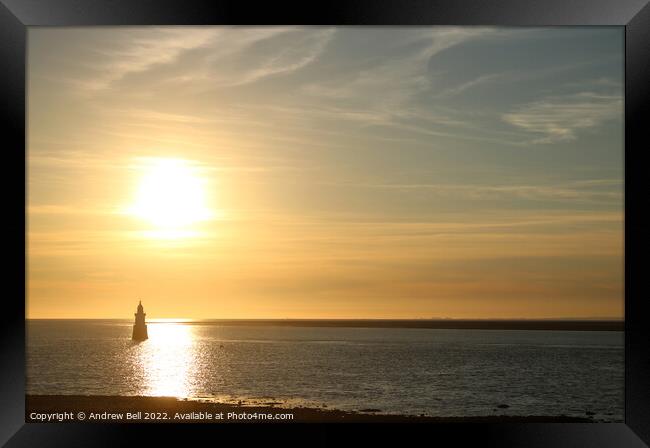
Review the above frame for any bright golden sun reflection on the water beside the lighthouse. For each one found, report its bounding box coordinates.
[138,323,196,397]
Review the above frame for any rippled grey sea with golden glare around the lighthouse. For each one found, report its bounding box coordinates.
[26,320,624,422]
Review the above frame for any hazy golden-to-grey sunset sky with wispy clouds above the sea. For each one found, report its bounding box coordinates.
[26,27,624,319]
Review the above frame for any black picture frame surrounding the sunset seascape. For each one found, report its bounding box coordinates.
[0,0,650,447]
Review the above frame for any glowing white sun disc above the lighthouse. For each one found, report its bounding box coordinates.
[129,158,213,233]
